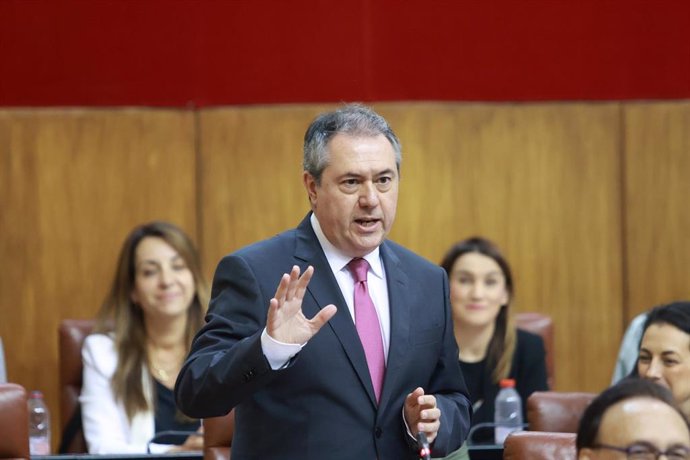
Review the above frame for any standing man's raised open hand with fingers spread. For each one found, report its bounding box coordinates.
[266,265,337,345]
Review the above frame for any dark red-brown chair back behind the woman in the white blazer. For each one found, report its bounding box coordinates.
[58,319,95,454]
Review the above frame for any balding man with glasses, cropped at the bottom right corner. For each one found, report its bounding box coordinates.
[576,378,690,460]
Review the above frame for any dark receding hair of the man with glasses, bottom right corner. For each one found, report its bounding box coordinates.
[575,378,690,452]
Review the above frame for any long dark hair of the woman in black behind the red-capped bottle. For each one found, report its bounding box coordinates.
[441,236,517,382]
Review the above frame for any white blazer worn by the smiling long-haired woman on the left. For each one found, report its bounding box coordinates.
[79,334,171,454]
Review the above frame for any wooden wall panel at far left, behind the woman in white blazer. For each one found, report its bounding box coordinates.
[0,110,196,450]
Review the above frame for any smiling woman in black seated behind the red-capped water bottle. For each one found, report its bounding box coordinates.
[441,237,548,443]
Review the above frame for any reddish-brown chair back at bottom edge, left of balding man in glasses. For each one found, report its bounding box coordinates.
[503,431,577,460]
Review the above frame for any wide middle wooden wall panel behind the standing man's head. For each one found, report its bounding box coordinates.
[200,103,622,391]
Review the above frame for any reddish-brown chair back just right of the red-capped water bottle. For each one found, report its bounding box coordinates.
[527,391,596,433]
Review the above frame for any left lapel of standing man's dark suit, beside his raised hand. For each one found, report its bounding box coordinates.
[295,214,376,406]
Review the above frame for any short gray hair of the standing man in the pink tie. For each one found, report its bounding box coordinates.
[302,104,402,184]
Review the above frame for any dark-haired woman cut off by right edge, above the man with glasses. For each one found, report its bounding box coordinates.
[637,302,690,418]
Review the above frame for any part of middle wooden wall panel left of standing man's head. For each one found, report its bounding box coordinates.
[199,105,329,276]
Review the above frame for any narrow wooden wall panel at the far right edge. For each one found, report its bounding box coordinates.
[624,101,690,321]
